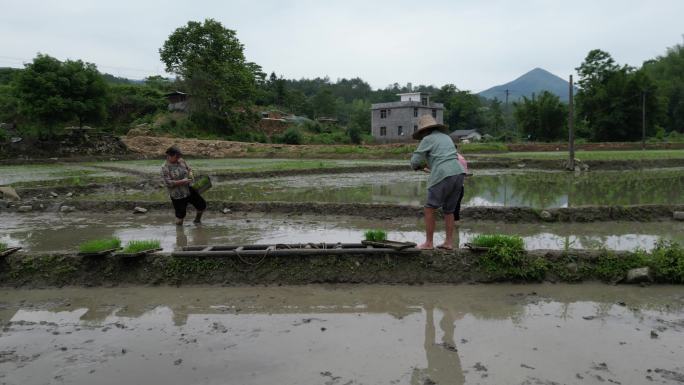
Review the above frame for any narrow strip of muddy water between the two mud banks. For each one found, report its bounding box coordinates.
[0,212,684,252]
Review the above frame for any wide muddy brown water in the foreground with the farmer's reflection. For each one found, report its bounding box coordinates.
[0,284,684,385]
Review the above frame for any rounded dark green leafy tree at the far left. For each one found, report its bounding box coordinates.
[13,54,108,134]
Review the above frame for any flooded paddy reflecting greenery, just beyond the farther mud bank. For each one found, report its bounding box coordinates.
[97,169,684,208]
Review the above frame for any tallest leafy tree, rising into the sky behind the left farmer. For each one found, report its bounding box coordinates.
[159,19,261,131]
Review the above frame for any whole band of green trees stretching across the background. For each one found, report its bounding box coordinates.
[0,19,684,143]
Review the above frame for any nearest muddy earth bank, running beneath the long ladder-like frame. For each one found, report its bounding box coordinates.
[0,249,667,288]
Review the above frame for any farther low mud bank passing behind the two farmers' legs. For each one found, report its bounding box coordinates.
[5,200,684,223]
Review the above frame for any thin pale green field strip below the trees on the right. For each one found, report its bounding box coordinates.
[488,150,684,160]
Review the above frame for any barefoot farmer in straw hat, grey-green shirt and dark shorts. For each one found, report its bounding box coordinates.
[411,115,465,250]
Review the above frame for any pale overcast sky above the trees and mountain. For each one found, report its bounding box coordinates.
[0,0,684,92]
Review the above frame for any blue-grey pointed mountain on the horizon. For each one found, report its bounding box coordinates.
[478,68,568,103]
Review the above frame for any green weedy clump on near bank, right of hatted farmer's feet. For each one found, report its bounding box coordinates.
[472,234,548,281]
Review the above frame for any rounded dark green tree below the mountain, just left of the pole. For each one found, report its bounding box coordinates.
[513,91,567,141]
